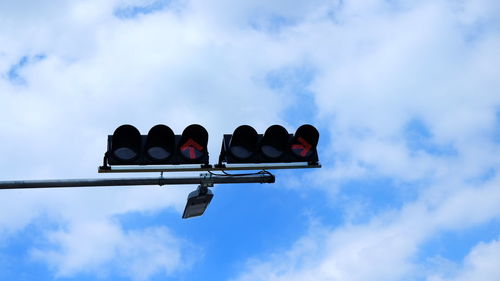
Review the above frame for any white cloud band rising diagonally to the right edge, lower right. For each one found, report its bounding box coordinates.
[235,174,500,281]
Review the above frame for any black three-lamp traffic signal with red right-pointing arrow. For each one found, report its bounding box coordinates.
[219,125,319,165]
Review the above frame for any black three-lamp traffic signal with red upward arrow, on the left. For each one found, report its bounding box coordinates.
[106,124,208,165]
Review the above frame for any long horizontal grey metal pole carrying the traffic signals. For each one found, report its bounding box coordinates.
[0,173,275,189]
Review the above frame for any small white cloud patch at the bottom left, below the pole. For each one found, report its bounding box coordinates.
[32,221,193,280]
